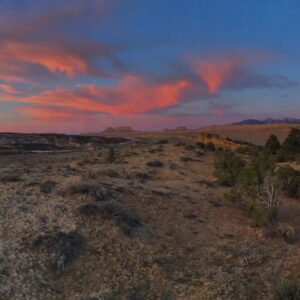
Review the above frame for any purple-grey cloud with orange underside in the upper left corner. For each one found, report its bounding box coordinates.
[0,0,124,83]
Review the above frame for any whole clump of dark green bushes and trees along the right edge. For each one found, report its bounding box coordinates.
[215,129,300,226]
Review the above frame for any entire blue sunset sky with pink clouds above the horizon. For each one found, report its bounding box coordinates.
[0,0,300,133]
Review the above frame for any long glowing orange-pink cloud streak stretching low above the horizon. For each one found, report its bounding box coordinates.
[11,75,189,115]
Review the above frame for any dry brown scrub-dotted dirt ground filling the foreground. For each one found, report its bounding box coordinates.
[0,142,300,300]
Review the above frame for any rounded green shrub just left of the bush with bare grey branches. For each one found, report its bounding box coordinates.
[215,151,245,186]
